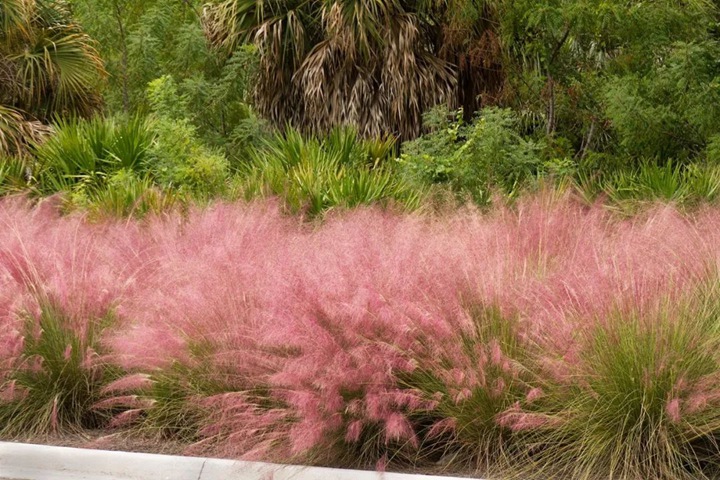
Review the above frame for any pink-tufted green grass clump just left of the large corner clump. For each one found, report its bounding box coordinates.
[401,306,549,474]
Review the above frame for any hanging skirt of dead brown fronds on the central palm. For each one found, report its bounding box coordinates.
[295,3,456,138]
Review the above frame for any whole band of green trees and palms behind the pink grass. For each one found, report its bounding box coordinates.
[0,0,720,214]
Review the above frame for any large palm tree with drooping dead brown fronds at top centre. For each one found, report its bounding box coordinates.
[204,0,473,138]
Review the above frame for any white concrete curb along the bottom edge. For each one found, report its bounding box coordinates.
[0,442,478,480]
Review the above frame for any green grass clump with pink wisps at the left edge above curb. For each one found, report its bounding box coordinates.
[0,299,119,436]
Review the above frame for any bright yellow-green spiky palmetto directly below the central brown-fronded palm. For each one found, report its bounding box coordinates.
[238,129,423,216]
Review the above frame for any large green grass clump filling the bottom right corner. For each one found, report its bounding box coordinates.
[531,286,720,479]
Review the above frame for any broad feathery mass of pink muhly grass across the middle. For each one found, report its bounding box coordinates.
[7,196,720,472]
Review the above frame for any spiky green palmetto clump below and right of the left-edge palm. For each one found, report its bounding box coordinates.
[26,116,179,216]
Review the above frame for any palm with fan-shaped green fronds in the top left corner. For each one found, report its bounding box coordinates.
[0,0,104,155]
